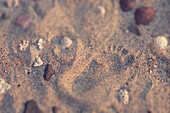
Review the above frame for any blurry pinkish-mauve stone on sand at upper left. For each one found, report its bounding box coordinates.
[15,14,32,29]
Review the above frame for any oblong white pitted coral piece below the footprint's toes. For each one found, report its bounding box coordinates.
[118,89,129,104]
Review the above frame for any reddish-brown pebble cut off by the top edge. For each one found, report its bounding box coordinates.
[120,0,136,11]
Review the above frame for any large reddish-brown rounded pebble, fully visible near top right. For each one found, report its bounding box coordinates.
[135,7,155,25]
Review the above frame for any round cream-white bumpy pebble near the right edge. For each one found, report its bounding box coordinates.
[154,36,168,49]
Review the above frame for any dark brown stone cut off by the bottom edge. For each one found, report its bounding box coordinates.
[24,100,42,113]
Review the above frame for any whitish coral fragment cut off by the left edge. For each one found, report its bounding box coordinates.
[0,78,11,94]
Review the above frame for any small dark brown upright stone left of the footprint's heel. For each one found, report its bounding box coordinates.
[44,64,55,81]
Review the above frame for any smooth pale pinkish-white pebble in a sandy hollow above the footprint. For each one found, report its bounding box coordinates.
[60,36,73,49]
